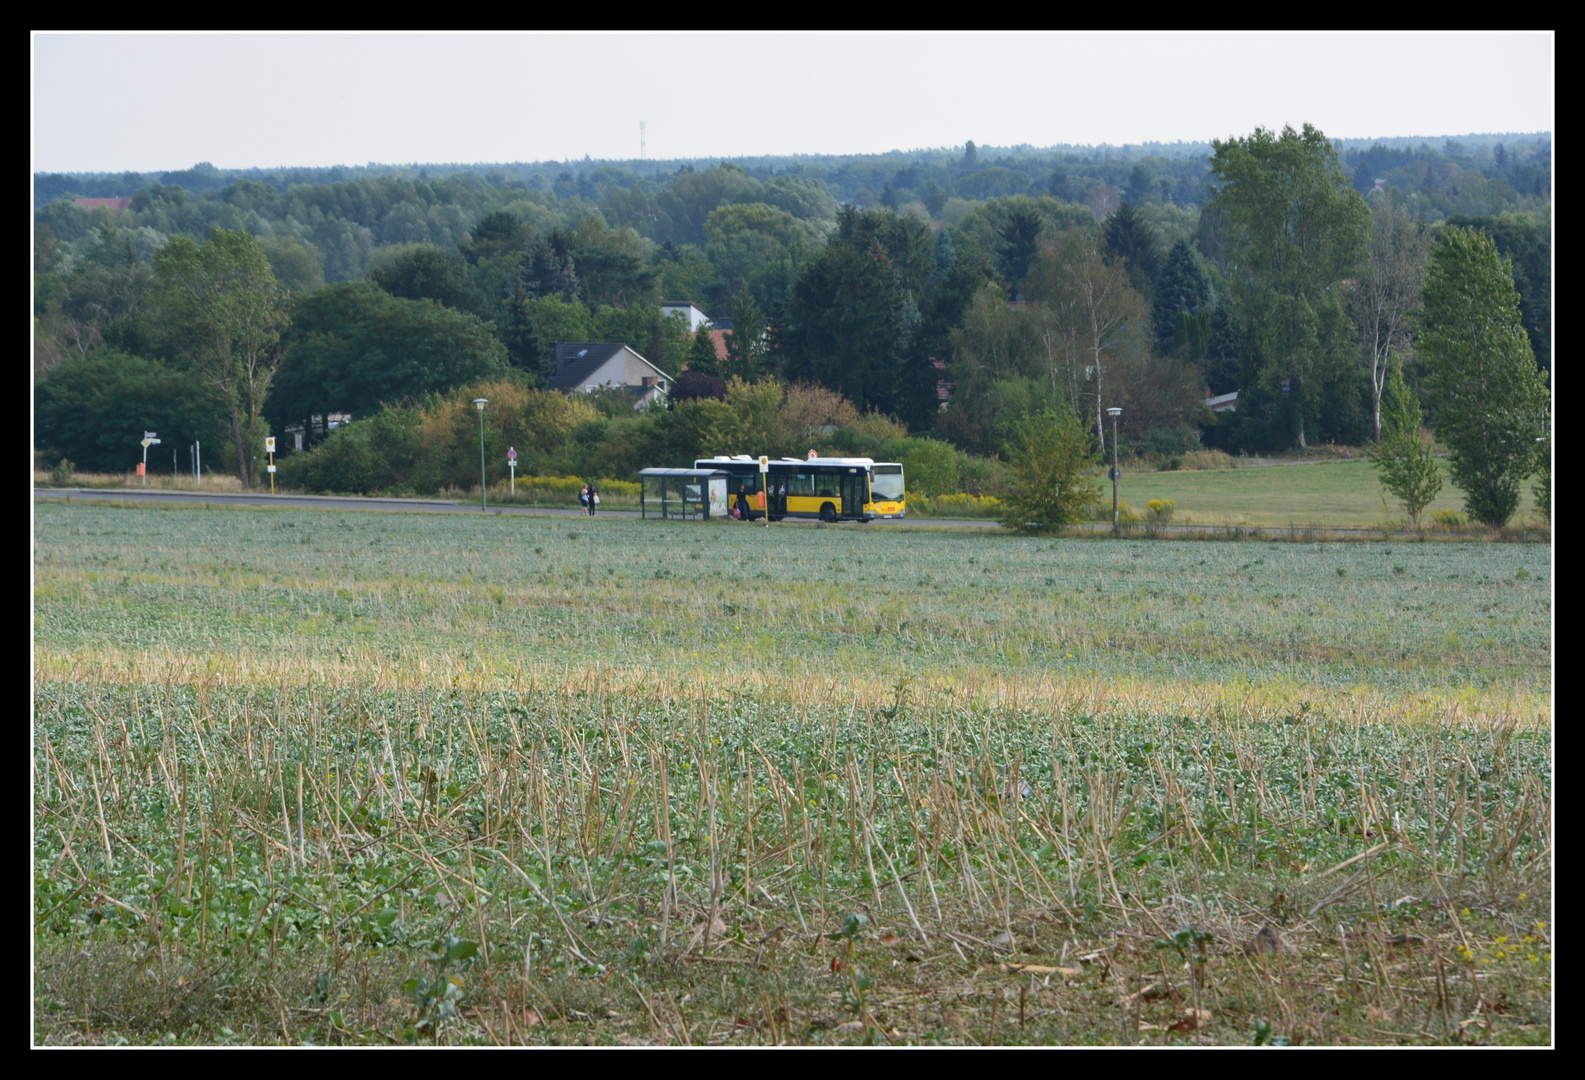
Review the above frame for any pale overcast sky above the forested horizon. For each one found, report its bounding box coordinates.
[32,33,1555,171]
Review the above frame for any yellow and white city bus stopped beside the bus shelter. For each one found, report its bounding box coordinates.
[694,454,908,523]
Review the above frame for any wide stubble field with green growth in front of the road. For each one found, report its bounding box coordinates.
[32,501,1552,1045]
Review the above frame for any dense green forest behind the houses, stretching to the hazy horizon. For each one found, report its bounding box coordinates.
[33,127,1552,497]
